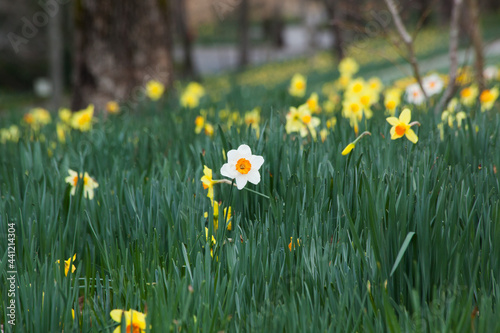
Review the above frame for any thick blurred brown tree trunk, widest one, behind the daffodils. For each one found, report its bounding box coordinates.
[72,0,172,110]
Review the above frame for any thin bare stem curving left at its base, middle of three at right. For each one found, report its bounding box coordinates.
[434,0,463,114]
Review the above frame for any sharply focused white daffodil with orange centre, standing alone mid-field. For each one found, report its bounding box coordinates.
[220,145,264,190]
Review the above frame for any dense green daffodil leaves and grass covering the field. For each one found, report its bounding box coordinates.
[0,54,500,332]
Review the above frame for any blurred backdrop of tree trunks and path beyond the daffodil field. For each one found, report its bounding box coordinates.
[0,0,500,110]
